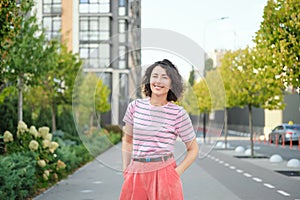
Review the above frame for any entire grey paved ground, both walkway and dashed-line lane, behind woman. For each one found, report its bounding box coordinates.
[35,141,300,200]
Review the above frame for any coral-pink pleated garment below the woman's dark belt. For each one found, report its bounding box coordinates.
[120,158,183,200]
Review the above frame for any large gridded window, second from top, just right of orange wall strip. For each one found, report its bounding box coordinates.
[79,17,110,43]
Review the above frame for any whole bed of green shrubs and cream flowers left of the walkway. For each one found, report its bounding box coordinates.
[0,122,121,199]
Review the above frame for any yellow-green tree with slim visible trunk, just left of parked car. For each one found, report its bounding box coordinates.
[231,47,283,157]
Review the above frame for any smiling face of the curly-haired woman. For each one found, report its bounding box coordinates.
[150,66,171,98]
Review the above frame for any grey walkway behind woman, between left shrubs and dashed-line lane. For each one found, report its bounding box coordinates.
[34,142,239,200]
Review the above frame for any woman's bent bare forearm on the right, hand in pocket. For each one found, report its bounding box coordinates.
[175,138,199,175]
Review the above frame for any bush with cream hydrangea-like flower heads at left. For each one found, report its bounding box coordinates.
[4,121,66,187]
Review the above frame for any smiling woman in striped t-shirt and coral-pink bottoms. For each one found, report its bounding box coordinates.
[120,59,198,200]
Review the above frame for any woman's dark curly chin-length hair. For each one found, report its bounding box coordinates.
[142,59,183,101]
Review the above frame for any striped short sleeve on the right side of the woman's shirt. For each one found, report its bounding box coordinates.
[175,108,196,142]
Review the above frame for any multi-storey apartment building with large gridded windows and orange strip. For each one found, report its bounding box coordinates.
[36,0,141,125]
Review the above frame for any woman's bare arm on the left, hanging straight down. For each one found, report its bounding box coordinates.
[122,123,132,171]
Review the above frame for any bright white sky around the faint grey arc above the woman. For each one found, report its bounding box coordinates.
[141,0,267,79]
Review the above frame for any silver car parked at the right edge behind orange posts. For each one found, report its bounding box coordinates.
[269,124,300,144]
